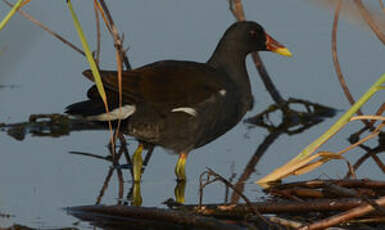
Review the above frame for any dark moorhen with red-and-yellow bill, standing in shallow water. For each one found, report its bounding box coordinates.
[65,21,292,181]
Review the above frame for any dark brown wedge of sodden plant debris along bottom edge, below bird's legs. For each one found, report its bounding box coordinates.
[67,205,245,230]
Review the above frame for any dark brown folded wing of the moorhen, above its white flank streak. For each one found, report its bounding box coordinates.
[83,61,224,108]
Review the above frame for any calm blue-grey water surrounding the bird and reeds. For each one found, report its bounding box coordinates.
[0,0,385,228]
